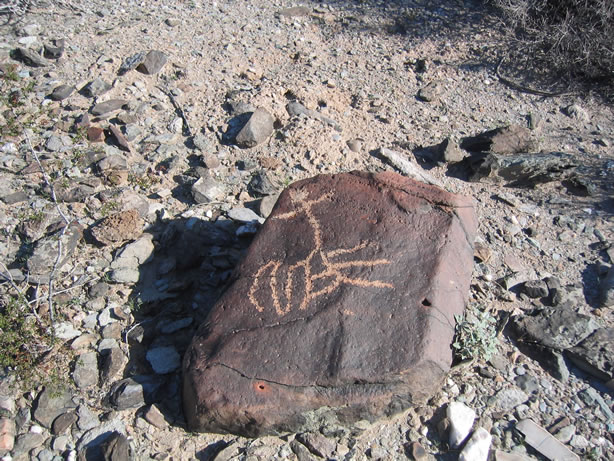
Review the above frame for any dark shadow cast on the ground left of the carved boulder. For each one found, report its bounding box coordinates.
[106,212,251,434]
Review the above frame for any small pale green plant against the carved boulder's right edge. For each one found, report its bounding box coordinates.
[452,305,499,360]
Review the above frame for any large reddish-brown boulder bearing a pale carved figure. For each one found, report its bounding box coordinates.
[183,172,477,437]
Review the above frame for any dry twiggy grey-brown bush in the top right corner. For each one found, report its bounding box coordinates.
[491,0,614,84]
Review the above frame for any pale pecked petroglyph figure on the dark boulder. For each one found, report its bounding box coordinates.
[248,190,394,315]
